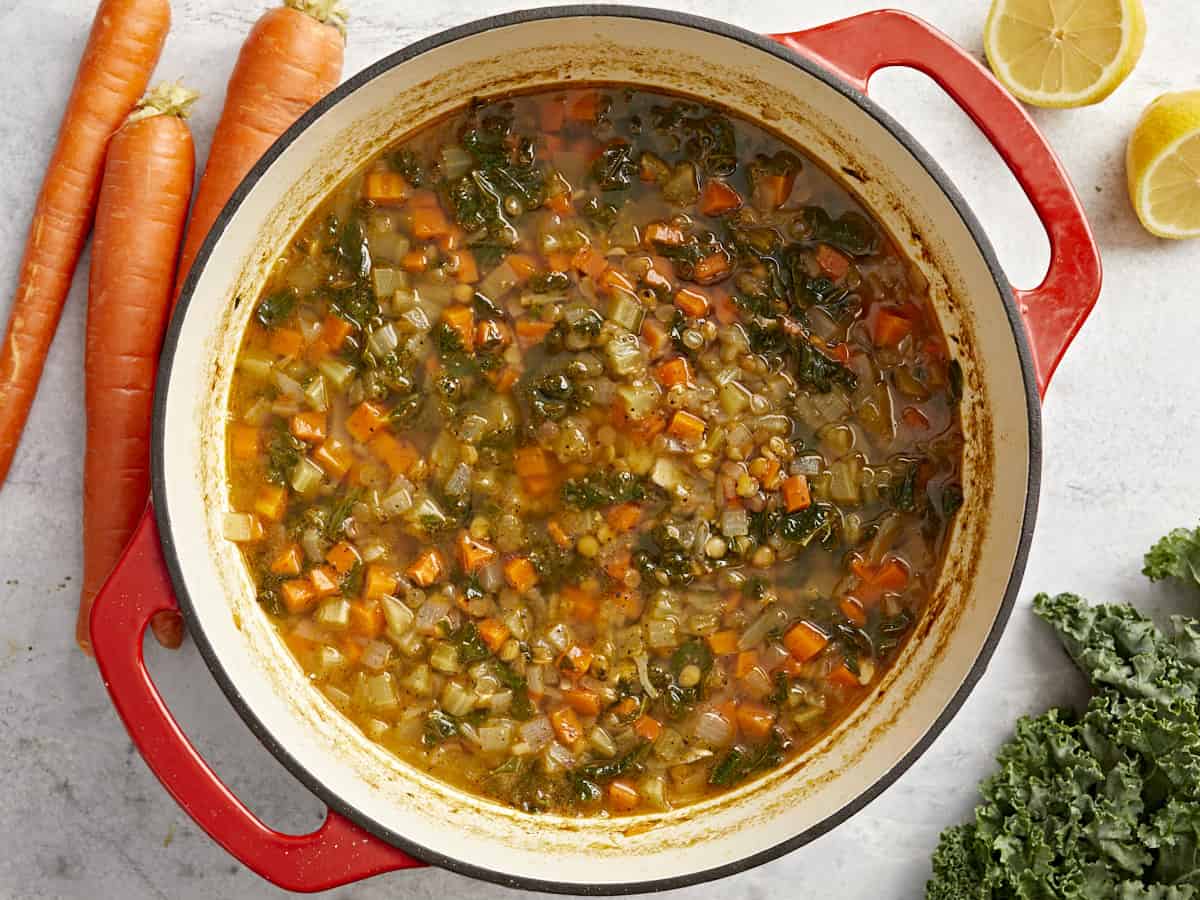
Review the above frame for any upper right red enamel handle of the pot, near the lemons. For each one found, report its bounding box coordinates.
[772,10,1100,395]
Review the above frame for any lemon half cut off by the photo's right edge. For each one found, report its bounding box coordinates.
[1126,90,1200,238]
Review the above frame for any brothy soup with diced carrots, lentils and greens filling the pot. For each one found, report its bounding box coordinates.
[226,86,962,815]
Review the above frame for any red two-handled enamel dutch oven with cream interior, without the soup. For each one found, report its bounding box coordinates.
[91,6,1100,894]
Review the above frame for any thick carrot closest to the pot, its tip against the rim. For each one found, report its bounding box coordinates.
[175,0,346,300]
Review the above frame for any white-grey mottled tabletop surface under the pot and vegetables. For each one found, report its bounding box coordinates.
[0,0,1200,900]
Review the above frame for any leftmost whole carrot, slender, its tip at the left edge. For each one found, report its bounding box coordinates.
[0,0,174,489]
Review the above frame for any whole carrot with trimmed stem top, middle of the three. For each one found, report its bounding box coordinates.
[76,84,195,652]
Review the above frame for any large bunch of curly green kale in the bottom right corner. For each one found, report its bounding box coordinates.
[925,594,1200,900]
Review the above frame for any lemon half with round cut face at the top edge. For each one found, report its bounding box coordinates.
[983,0,1146,107]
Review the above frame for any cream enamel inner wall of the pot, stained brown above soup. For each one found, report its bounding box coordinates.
[156,10,1030,890]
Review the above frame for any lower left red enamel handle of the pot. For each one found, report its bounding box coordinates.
[91,506,424,892]
